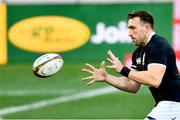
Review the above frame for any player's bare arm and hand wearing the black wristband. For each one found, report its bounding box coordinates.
[107,50,166,88]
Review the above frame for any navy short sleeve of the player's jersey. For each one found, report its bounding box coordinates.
[148,44,167,66]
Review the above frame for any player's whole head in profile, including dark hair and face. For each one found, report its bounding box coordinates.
[128,11,154,45]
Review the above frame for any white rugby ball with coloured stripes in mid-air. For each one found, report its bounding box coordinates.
[33,53,64,78]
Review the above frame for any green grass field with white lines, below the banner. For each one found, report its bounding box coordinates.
[0,63,154,119]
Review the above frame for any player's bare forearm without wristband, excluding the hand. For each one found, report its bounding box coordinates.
[105,74,140,93]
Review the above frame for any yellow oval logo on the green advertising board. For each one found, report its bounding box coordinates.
[9,16,90,52]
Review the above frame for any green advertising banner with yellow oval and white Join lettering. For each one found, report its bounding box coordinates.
[8,3,172,62]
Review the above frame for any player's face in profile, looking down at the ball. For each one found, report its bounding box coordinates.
[128,17,146,45]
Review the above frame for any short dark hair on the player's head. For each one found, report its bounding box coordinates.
[128,11,154,29]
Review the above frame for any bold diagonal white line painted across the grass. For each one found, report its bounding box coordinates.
[0,87,118,115]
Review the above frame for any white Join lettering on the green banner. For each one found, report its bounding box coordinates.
[91,21,132,44]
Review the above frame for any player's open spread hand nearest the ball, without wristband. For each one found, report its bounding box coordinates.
[82,61,107,85]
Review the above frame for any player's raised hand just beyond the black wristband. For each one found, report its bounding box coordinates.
[106,50,123,73]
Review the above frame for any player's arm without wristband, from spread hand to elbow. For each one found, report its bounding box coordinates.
[82,62,140,93]
